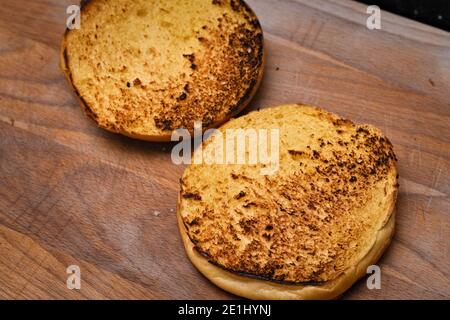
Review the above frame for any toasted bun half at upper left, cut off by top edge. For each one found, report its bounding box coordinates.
[61,0,265,141]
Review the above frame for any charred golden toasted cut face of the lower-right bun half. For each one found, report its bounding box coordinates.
[179,105,397,283]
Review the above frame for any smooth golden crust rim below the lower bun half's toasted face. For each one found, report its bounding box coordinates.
[177,198,395,300]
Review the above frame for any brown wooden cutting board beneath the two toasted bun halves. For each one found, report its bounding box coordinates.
[0,0,450,299]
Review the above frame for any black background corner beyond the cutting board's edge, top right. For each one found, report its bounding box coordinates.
[357,0,450,31]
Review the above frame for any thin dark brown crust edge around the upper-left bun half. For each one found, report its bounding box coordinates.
[60,0,266,142]
